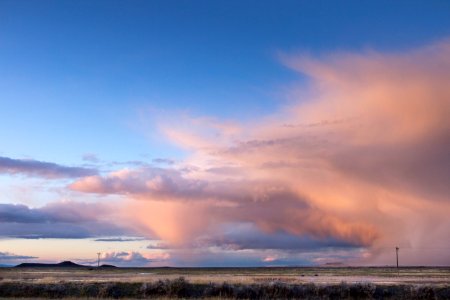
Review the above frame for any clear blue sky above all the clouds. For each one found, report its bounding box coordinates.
[0,1,450,163]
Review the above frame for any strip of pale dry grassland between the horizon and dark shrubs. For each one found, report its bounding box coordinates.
[0,267,450,286]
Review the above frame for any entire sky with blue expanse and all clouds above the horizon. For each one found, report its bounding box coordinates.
[0,0,450,267]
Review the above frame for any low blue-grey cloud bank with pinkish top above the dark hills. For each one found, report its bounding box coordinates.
[0,201,133,239]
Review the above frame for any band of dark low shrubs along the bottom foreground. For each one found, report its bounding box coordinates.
[0,277,450,299]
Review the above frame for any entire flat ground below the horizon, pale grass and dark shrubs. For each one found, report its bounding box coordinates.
[0,267,450,299]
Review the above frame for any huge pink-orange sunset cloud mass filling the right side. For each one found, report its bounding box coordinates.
[70,41,450,265]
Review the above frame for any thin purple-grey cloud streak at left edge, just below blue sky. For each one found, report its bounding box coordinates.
[0,157,98,179]
